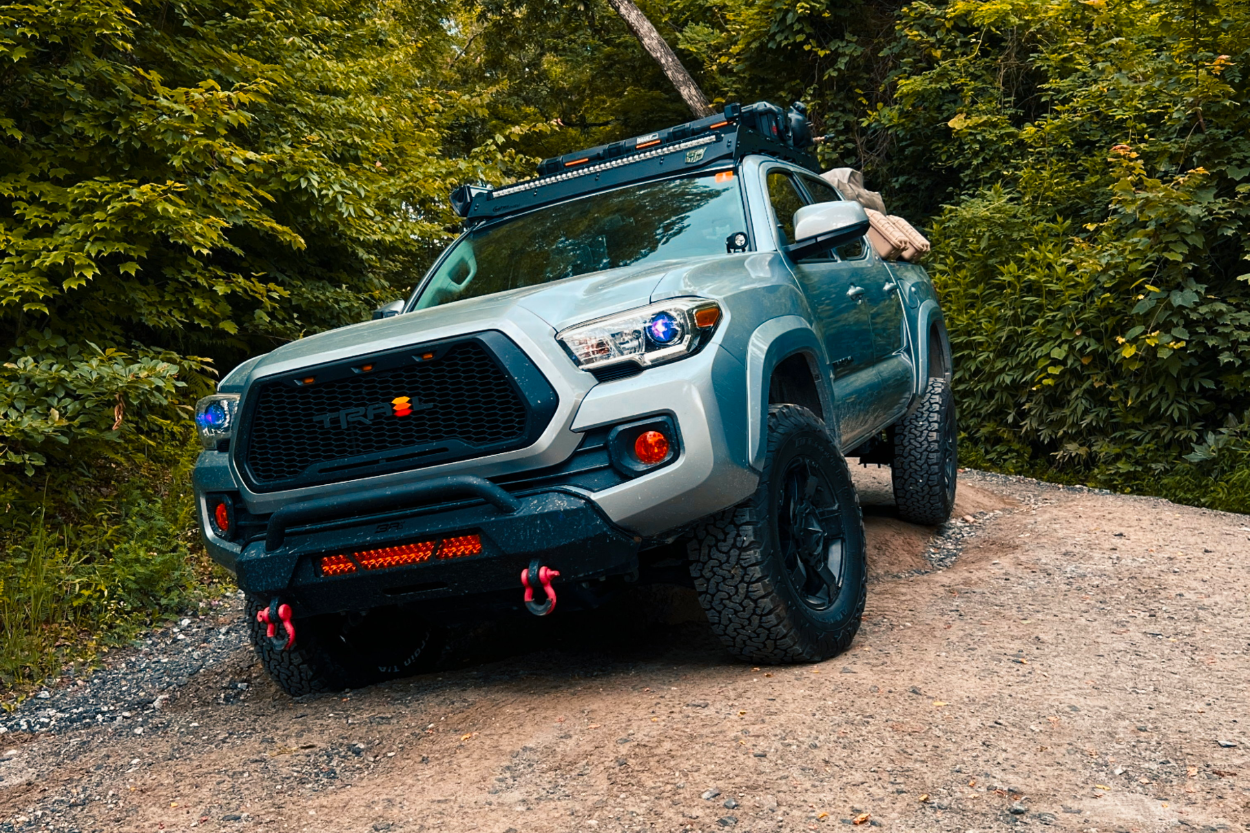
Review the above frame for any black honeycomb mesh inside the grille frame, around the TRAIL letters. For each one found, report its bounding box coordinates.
[245,341,526,487]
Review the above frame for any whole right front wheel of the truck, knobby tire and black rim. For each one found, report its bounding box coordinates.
[689,405,866,663]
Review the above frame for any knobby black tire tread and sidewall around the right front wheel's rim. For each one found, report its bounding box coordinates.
[689,405,866,663]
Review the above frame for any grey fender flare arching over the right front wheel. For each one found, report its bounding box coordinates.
[746,315,840,472]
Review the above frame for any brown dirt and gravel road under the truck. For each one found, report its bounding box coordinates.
[0,472,1250,833]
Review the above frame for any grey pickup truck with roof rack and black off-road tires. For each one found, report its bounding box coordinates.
[195,103,956,695]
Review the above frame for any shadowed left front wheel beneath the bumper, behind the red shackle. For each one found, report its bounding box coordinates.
[246,597,441,697]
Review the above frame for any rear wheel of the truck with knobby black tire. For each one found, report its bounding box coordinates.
[893,379,959,527]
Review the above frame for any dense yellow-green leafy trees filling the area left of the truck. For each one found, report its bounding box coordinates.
[0,0,510,495]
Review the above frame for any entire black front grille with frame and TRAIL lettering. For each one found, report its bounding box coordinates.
[239,334,555,490]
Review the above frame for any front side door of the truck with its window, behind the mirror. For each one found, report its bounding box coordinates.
[766,168,876,448]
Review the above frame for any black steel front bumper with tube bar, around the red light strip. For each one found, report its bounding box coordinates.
[233,478,639,615]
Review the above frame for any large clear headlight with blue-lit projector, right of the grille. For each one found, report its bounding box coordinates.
[556,298,720,370]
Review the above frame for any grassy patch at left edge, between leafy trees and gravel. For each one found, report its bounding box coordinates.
[0,450,226,695]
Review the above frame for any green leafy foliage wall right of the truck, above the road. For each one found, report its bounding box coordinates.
[873,0,1250,512]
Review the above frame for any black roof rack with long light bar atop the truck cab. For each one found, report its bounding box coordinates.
[451,101,820,220]
